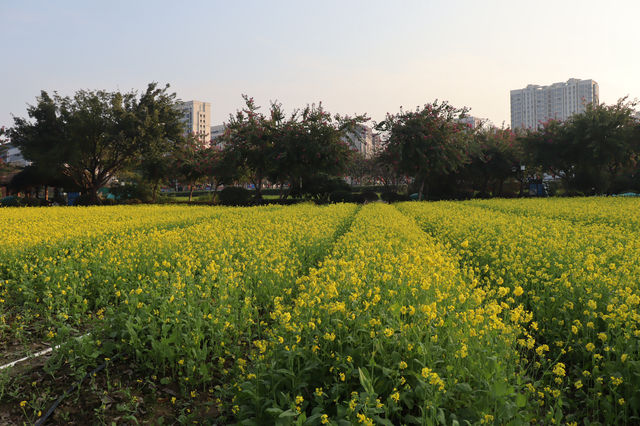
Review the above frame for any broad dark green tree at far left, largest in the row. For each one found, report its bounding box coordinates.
[10,83,183,203]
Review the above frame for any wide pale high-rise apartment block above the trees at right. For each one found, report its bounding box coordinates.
[511,78,599,129]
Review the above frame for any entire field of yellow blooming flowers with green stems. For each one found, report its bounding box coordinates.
[0,198,640,425]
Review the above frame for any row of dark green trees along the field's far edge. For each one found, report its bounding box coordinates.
[0,83,640,204]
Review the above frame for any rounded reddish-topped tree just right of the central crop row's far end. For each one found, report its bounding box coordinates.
[376,100,471,200]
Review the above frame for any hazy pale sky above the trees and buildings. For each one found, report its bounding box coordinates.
[0,0,640,126]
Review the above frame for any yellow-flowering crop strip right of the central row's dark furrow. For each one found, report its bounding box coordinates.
[399,201,640,424]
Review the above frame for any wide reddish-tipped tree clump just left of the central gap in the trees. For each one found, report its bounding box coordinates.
[222,96,367,198]
